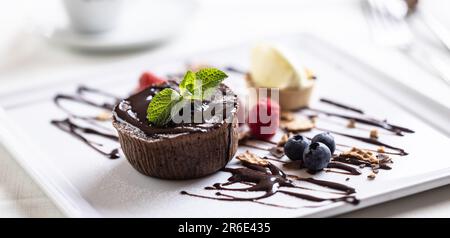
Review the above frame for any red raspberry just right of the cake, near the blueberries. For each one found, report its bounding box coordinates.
[247,99,280,140]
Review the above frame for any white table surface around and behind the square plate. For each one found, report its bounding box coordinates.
[0,0,450,217]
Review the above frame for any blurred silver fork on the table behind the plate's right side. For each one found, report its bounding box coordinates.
[364,0,450,86]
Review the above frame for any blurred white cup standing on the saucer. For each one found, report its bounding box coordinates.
[64,0,122,33]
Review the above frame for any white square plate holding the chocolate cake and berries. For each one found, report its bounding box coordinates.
[0,35,450,217]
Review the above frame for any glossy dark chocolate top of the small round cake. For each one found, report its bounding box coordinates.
[113,80,237,139]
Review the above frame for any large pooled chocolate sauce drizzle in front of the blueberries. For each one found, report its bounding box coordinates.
[181,162,359,208]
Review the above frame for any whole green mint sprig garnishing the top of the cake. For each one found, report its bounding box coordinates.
[147,68,228,127]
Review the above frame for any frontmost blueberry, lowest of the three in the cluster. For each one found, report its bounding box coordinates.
[303,142,331,171]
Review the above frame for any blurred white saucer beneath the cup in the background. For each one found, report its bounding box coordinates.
[49,0,195,52]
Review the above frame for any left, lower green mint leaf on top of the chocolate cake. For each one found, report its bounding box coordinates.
[147,88,183,126]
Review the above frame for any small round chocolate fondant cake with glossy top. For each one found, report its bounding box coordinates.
[113,81,238,179]
